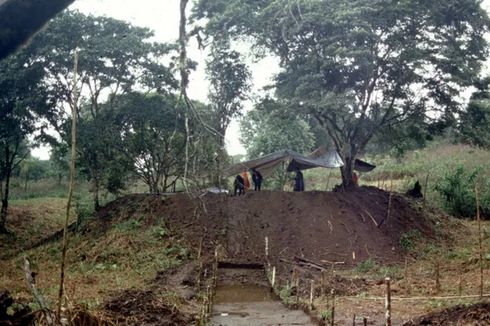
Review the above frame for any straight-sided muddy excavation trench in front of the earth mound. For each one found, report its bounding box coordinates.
[211,263,316,326]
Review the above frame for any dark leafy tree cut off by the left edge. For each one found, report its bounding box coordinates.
[0,51,52,233]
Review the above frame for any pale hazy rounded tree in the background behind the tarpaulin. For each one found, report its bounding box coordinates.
[240,98,315,158]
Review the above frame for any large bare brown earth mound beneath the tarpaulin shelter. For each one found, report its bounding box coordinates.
[97,187,435,266]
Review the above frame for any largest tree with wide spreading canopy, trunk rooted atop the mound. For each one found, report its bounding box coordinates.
[195,0,489,186]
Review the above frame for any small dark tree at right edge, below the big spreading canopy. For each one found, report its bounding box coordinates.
[459,79,490,148]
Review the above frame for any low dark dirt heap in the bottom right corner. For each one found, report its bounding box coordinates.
[404,302,490,326]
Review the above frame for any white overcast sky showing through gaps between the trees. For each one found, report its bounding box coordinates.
[33,0,490,159]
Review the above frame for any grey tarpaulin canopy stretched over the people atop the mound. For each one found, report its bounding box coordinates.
[224,147,376,176]
